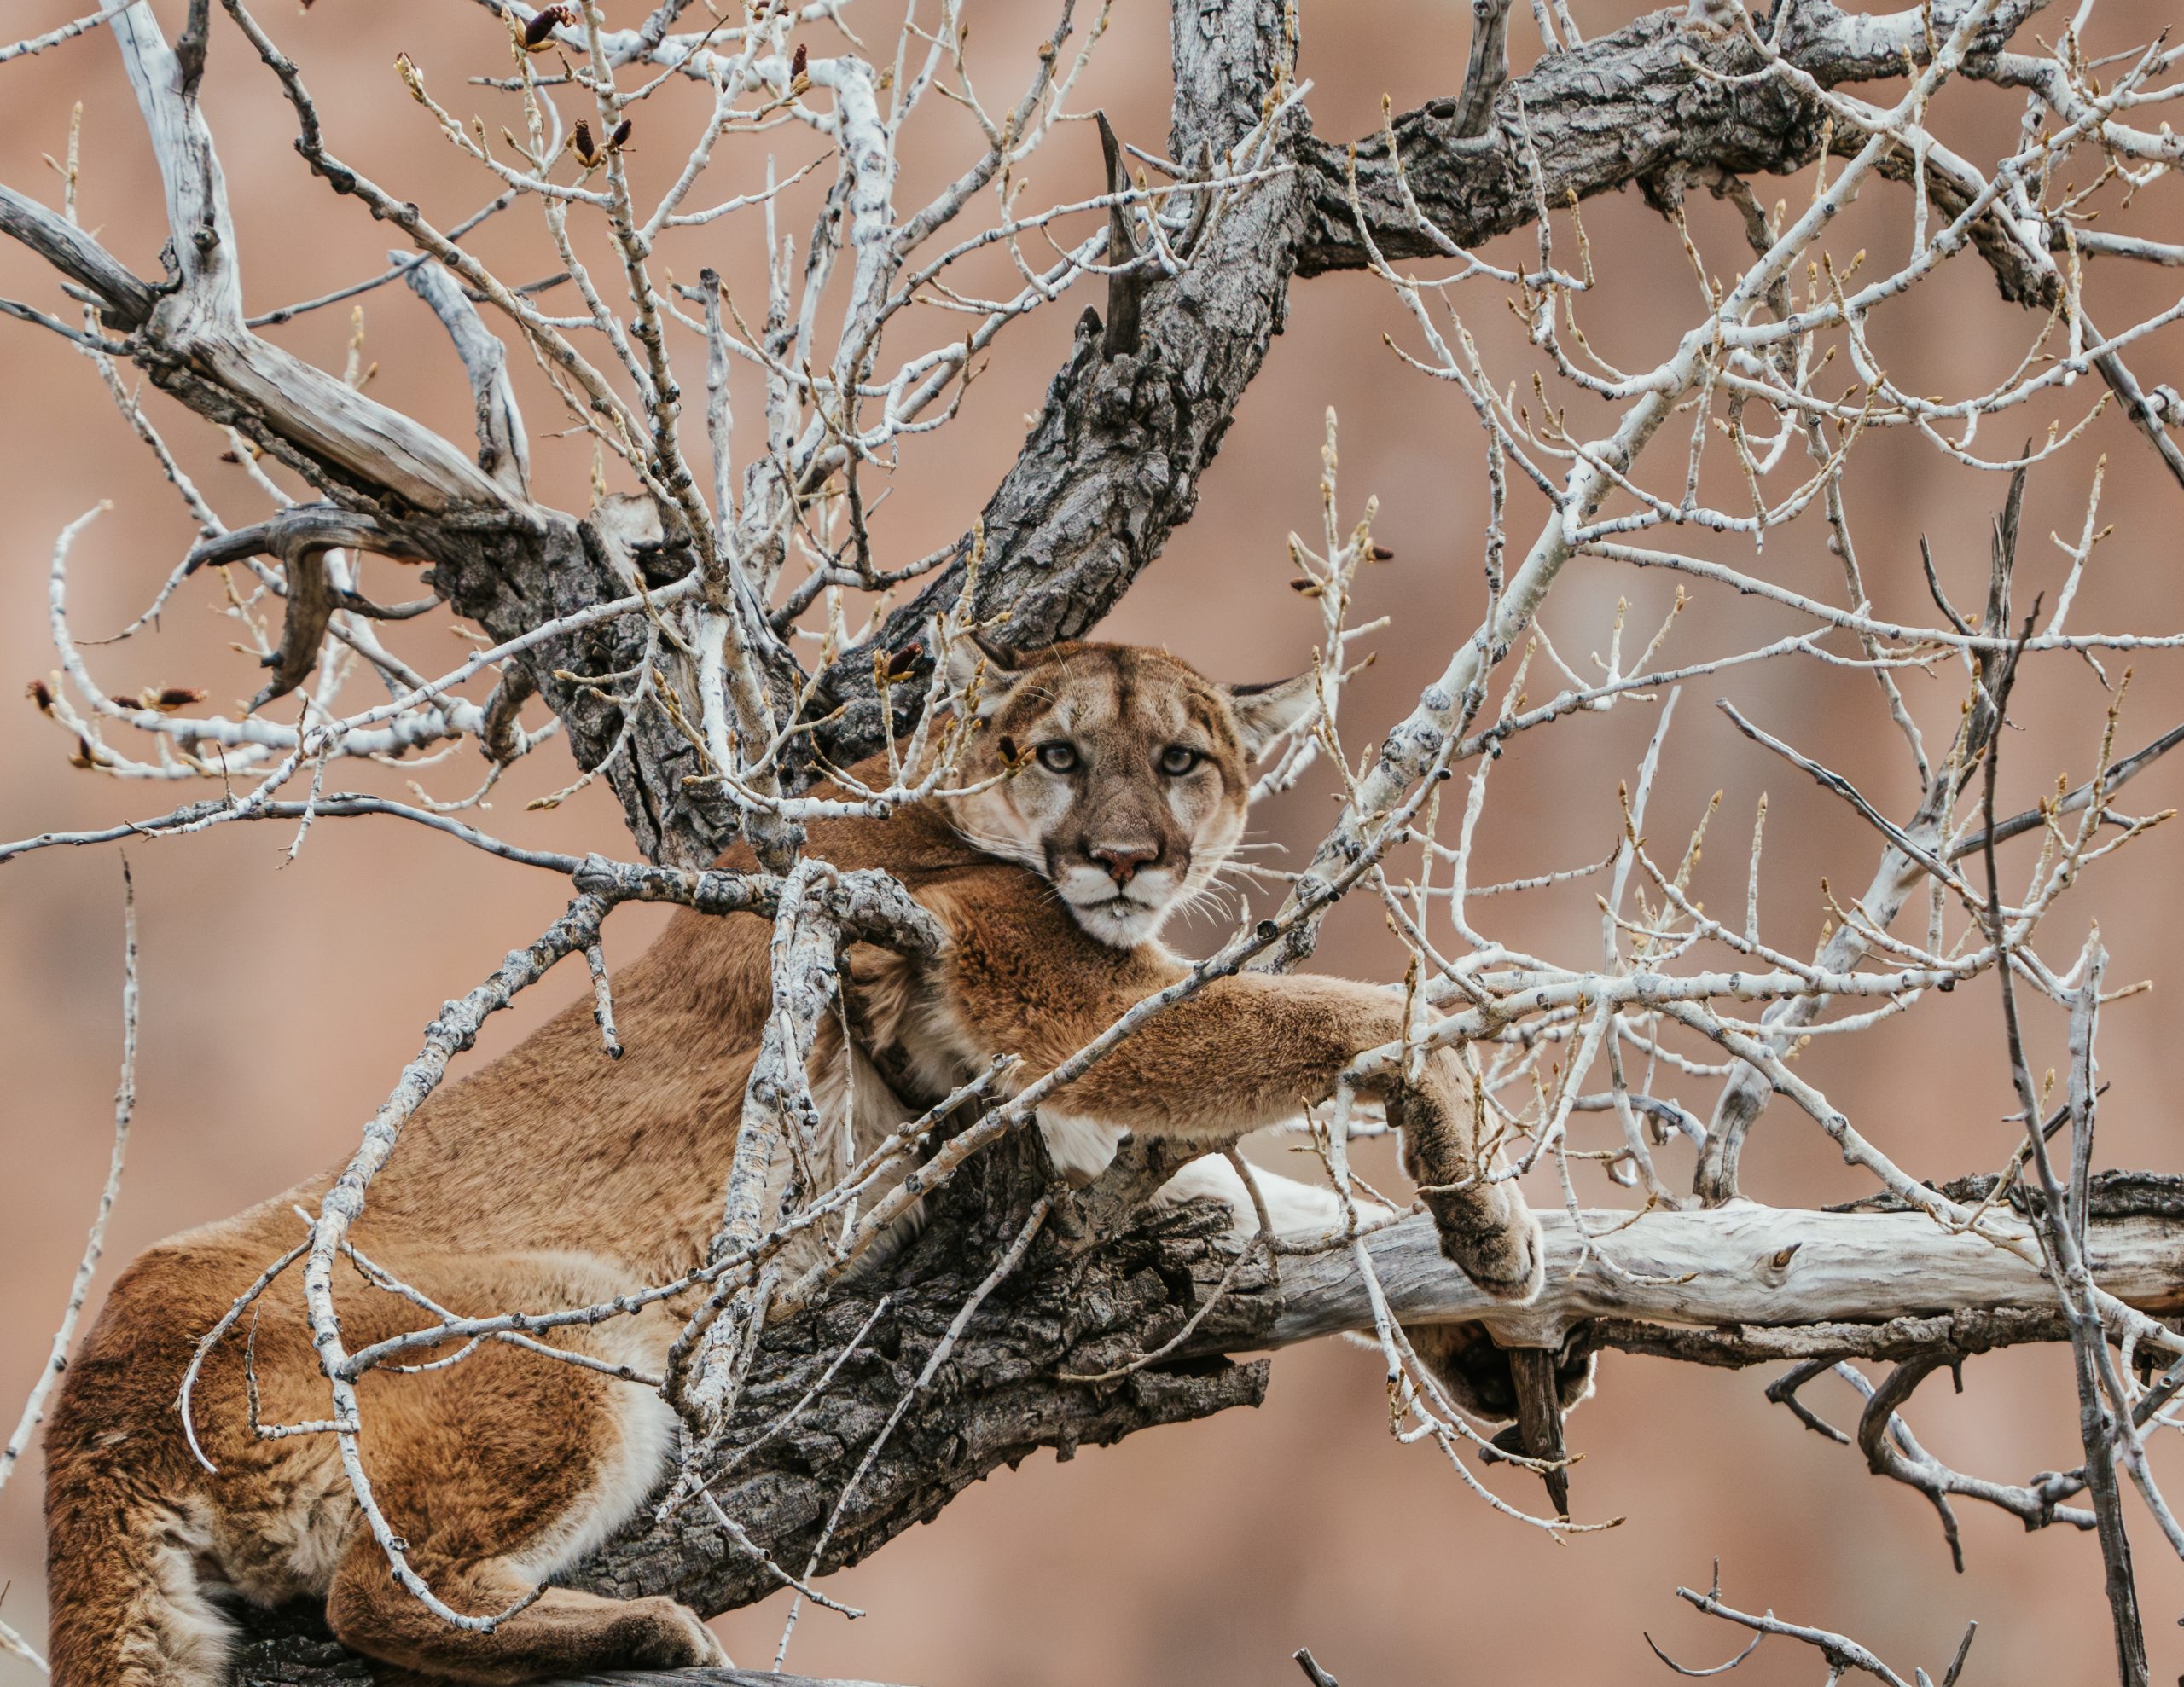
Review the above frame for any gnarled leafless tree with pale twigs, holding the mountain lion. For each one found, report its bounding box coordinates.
[0,0,2184,1683]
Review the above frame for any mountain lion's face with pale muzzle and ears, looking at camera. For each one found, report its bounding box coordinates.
[952,641,1315,949]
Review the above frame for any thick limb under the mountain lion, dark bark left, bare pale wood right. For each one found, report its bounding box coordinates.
[243,1141,2184,1687]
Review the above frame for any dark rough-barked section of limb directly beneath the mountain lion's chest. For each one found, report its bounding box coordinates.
[566,1139,1275,1610]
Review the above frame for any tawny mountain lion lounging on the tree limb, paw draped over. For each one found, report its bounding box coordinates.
[46,646,1540,1687]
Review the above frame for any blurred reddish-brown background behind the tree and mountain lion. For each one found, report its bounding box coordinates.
[0,0,2184,1687]
